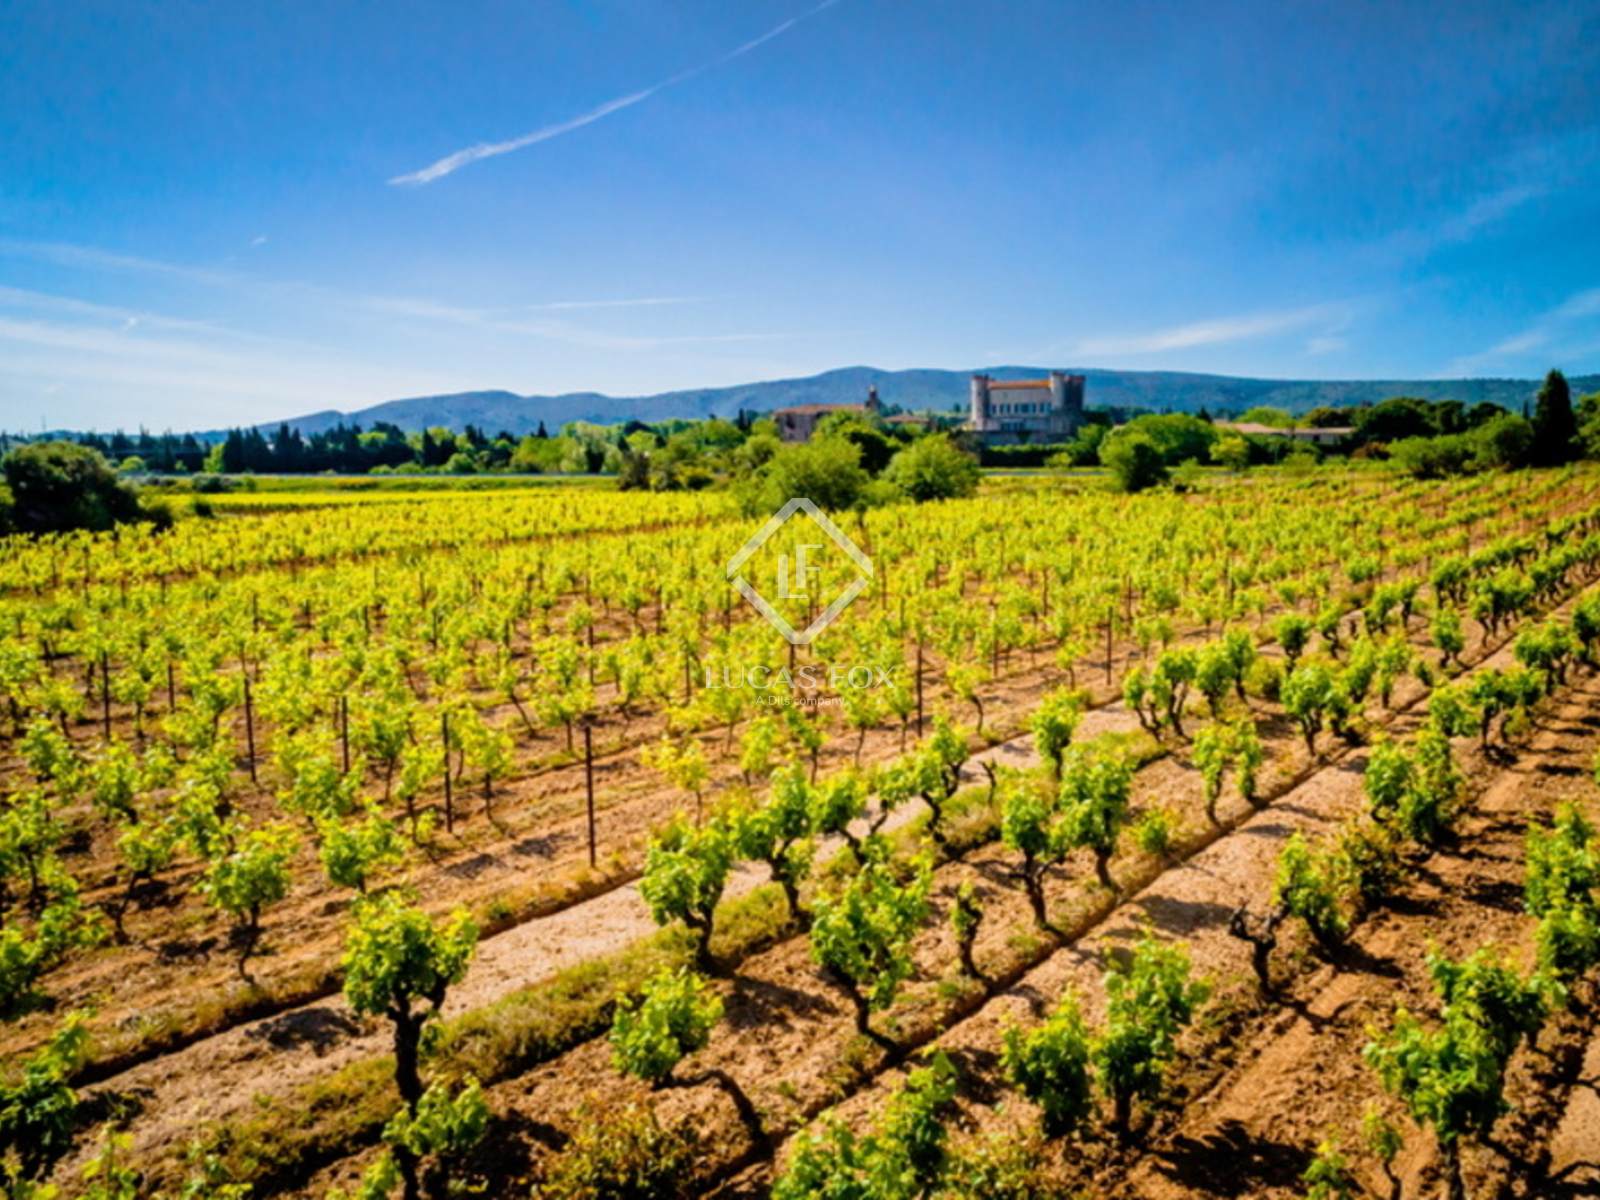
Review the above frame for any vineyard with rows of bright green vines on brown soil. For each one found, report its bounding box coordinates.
[9,466,1600,1200]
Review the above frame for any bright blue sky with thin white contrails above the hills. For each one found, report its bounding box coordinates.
[0,0,1600,429]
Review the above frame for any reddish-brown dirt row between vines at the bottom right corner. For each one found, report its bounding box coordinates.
[1096,675,1600,1200]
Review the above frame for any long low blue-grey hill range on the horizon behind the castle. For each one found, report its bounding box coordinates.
[252,366,1600,434]
